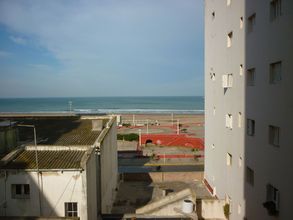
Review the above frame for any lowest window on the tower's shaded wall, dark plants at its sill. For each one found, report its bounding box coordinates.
[263,184,280,215]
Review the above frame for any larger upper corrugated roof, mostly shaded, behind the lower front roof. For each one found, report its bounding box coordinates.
[0,116,108,146]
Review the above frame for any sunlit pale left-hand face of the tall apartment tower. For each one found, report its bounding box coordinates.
[205,0,245,219]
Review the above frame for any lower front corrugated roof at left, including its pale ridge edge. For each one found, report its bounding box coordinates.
[0,147,87,170]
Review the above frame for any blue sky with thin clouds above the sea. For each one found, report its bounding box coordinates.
[0,0,204,98]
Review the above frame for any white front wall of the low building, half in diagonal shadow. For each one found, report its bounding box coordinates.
[0,171,88,220]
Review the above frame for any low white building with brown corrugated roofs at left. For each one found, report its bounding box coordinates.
[0,116,118,220]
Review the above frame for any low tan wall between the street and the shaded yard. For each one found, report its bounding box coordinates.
[120,172,203,183]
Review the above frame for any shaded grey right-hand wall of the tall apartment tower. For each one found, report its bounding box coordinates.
[245,0,293,220]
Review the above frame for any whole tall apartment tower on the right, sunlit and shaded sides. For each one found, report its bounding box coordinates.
[205,0,293,220]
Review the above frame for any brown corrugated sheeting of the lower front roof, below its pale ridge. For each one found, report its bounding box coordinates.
[1,150,86,170]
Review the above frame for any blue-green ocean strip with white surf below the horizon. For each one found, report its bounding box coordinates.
[0,96,204,114]
